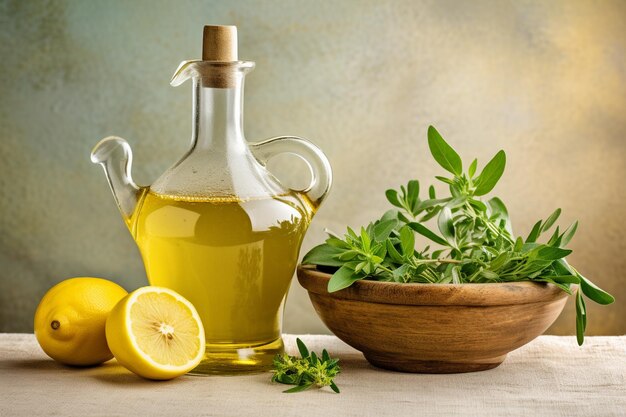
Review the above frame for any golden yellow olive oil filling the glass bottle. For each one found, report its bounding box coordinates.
[128,189,313,373]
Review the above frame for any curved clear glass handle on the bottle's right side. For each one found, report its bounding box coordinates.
[250,136,333,207]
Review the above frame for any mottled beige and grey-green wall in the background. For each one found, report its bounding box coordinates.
[0,0,626,334]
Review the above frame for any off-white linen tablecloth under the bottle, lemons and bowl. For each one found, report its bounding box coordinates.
[0,334,626,417]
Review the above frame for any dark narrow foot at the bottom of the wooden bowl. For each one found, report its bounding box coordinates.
[364,353,506,374]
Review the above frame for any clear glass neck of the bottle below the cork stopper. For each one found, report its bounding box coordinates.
[192,72,245,151]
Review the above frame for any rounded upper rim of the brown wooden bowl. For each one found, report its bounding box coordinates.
[297,265,574,306]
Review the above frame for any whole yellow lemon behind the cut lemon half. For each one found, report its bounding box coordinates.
[35,277,128,366]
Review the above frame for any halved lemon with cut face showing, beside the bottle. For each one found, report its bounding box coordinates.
[106,287,205,379]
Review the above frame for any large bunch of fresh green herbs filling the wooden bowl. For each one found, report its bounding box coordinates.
[302,126,614,345]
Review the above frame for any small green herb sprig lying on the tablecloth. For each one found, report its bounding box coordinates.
[272,339,341,393]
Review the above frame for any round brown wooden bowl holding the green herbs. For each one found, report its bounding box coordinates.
[298,266,567,373]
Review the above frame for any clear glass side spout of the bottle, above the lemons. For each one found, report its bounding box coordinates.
[91,136,140,220]
